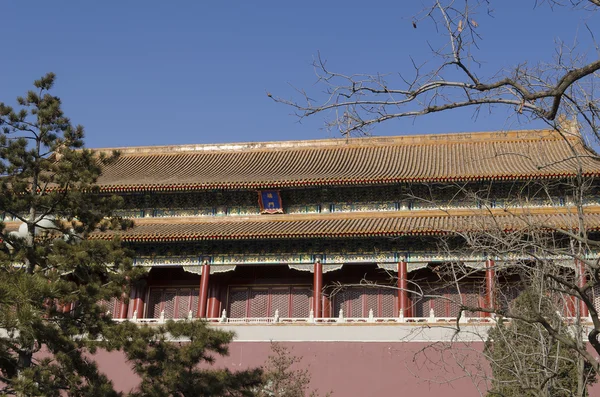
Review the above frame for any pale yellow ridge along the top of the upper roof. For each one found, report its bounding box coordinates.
[92,129,568,155]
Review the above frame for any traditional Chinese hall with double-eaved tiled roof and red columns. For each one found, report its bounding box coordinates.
[78,131,600,395]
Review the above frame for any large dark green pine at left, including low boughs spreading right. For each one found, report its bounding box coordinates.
[0,73,261,397]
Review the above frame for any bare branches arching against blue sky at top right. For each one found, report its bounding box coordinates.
[268,0,600,144]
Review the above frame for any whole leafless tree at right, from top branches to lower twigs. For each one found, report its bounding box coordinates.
[268,0,600,396]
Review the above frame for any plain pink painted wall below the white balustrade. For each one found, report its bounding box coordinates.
[95,342,485,397]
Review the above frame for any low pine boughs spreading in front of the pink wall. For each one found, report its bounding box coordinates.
[118,320,262,397]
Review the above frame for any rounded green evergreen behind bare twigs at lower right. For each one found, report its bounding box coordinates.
[485,287,596,397]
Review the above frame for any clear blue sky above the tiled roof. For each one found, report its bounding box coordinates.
[0,0,600,147]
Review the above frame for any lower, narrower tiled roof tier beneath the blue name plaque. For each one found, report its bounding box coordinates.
[85,207,600,242]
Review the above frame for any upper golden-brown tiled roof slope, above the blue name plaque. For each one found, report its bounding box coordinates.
[98,130,600,191]
